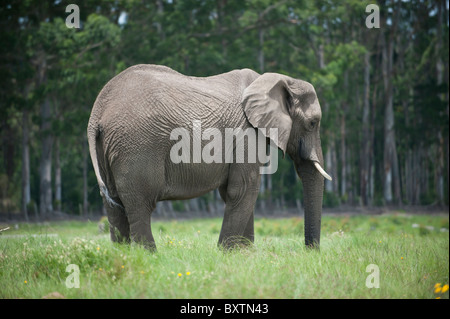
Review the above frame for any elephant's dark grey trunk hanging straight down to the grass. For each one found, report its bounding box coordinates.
[297,154,324,248]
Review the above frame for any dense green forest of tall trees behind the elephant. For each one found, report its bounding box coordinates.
[0,0,449,220]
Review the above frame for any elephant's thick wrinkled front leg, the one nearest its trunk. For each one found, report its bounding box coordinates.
[219,164,261,249]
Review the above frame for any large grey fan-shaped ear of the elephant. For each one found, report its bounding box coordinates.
[242,73,292,155]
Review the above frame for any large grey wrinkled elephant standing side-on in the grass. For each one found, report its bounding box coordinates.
[87,64,331,251]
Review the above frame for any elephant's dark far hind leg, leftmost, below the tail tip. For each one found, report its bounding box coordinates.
[103,199,130,243]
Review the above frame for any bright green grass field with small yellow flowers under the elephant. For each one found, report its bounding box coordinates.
[0,213,449,299]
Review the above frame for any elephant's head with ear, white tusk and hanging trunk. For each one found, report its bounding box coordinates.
[242,73,331,247]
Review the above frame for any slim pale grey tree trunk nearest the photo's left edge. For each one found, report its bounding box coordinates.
[22,109,31,221]
